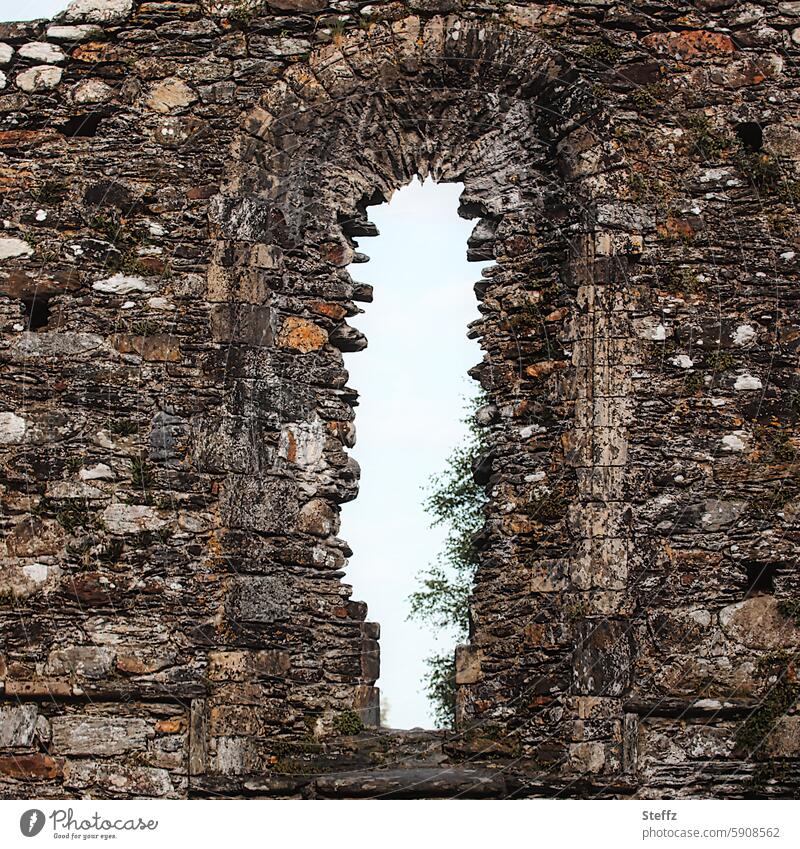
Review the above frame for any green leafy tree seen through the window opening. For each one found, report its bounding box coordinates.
[409,393,487,727]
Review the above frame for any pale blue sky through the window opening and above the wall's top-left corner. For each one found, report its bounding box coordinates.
[0,0,481,728]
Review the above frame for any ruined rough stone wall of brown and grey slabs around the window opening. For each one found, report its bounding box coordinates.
[0,0,800,799]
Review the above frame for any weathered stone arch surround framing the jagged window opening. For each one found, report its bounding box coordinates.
[202,17,643,772]
